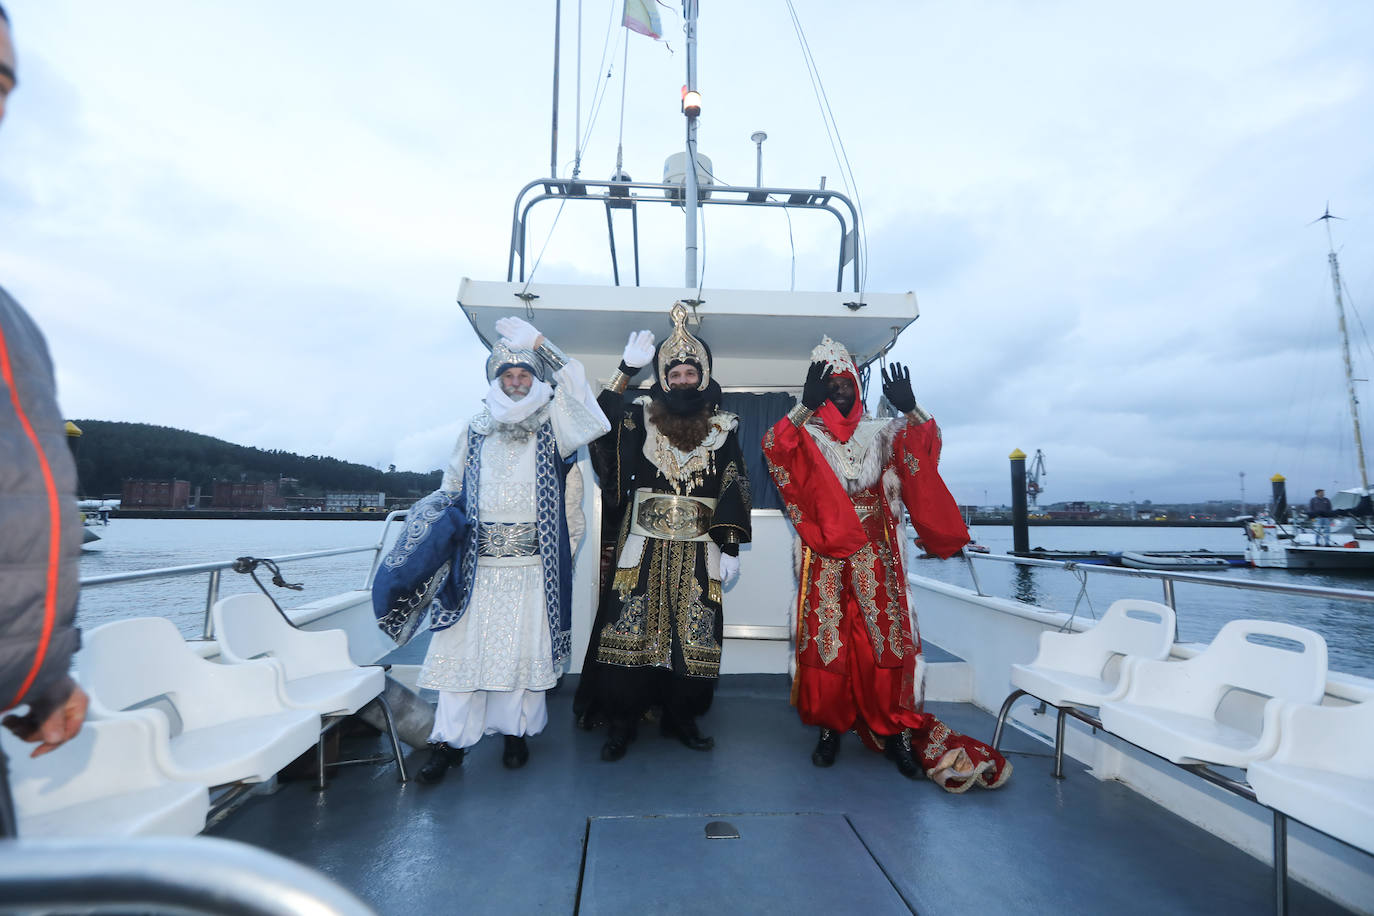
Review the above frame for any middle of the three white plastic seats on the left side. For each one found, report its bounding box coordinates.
[77,617,320,787]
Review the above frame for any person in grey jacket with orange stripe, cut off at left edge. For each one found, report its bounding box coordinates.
[0,7,87,836]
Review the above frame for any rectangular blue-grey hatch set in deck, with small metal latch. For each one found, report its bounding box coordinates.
[577,813,912,916]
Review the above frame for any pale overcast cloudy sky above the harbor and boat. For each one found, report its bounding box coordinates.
[0,0,1374,503]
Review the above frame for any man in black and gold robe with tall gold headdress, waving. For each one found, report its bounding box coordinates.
[576,304,750,761]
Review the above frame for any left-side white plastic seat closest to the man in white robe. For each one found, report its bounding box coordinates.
[210,593,405,788]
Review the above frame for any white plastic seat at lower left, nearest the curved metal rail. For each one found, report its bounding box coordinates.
[0,720,210,838]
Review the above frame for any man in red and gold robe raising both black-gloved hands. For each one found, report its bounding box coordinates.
[763,336,1011,791]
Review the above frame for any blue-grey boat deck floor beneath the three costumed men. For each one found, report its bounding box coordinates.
[207,661,1345,916]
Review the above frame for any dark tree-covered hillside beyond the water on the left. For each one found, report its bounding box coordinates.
[66,420,442,497]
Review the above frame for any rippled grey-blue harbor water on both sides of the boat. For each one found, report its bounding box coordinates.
[77,519,1374,677]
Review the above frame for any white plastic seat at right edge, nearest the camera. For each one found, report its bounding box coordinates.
[1245,700,1374,853]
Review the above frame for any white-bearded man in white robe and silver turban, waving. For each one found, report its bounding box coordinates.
[419,317,610,783]
